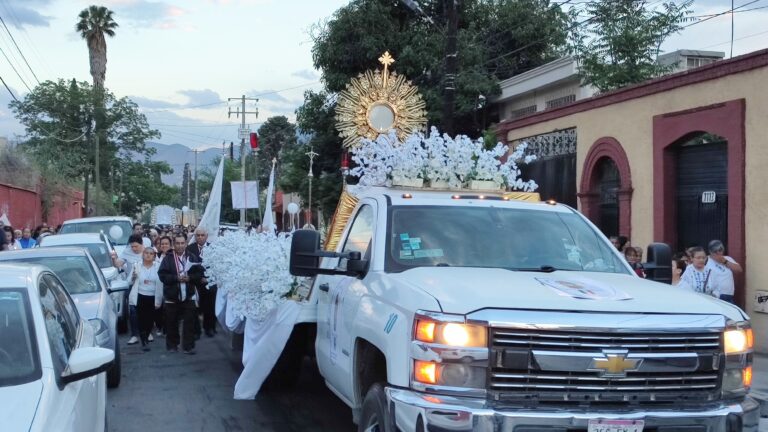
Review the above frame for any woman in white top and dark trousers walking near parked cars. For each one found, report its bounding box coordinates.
[128,248,163,351]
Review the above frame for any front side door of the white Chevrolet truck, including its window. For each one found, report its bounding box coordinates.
[315,203,376,401]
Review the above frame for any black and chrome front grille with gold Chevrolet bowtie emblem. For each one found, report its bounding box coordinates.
[488,328,722,405]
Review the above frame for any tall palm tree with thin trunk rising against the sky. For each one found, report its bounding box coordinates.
[75,5,117,208]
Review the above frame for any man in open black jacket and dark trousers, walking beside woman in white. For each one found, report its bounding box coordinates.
[157,234,197,354]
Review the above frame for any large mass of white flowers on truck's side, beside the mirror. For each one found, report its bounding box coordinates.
[203,231,295,322]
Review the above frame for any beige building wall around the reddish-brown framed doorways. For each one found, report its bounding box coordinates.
[507,68,768,352]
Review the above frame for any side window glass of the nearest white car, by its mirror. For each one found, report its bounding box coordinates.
[39,277,77,375]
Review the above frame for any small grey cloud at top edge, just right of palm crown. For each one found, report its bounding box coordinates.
[107,0,187,30]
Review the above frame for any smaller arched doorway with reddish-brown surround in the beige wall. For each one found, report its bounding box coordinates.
[578,137,632,237]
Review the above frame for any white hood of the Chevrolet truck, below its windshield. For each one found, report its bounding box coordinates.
[387,267,746,321]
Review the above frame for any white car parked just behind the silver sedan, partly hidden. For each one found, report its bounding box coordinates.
[40,233,130,333]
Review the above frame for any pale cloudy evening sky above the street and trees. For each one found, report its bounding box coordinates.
[0,0,768,149]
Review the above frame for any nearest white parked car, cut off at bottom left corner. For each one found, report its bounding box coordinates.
[0,264,115,432]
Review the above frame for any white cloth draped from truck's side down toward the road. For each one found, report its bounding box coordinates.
[235,300,301,399]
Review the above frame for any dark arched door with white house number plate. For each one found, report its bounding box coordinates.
[675,132,728,250]
